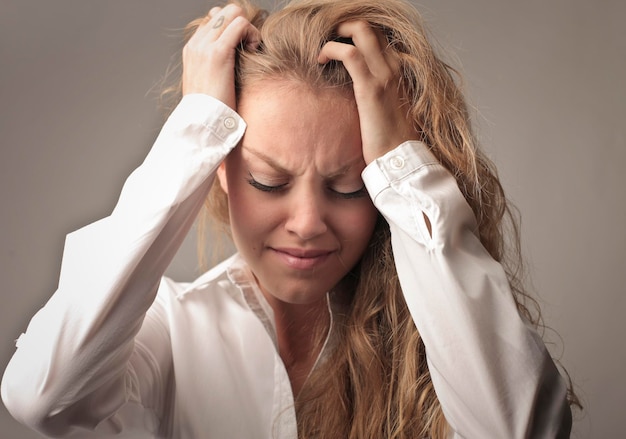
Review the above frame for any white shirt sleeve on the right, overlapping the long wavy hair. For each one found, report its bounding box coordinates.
[363,142,571,438]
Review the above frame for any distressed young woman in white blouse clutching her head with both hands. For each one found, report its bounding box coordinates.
[2,0,571,438]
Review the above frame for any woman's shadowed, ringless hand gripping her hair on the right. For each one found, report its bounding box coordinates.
[318,21,419,164]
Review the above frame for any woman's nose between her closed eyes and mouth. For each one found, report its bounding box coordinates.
[285,190,328,240]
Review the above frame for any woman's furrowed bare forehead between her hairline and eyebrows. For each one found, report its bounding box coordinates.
[237,80,362,173]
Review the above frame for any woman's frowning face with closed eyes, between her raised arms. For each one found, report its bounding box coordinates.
[218,81,377,304]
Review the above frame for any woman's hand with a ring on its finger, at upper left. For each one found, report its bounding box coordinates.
[183,4,260,109]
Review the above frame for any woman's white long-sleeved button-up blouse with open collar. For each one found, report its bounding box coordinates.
[2,95,571,439]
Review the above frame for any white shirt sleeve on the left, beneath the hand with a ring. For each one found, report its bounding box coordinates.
[2,95,245,436]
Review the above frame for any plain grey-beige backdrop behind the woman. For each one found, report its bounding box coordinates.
[0,0,626,439]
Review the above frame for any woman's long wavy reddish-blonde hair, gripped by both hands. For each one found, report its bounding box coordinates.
[172,0,576,438]
